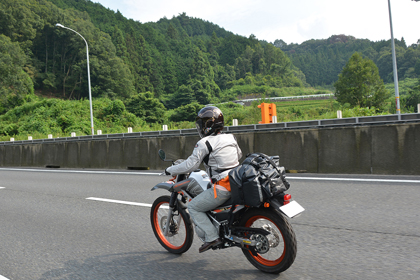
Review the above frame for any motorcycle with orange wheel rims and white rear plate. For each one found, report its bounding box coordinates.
[150,150,304,274]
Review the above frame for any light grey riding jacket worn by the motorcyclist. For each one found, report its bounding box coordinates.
[166,134,242,182]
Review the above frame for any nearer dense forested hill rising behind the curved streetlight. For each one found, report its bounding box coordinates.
[0,0,303,108]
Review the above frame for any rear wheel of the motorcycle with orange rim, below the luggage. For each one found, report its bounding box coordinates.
[241,209,297,273]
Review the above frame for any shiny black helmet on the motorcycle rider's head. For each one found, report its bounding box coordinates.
[195,106,225,138]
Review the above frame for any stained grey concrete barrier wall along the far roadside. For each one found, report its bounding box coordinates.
[0,123,420,175]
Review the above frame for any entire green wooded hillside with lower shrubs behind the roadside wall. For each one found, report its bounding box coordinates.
[0,0,420,139]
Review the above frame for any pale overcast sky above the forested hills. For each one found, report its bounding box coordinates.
[91,0,420,46]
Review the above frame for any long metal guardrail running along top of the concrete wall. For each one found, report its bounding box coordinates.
[0,113,420,145]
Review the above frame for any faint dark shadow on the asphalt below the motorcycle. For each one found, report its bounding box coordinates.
[40,251,282,280]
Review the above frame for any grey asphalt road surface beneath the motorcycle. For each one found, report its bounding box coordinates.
[0,168,420,280]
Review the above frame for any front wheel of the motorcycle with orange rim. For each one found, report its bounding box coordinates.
[150,196,194,254]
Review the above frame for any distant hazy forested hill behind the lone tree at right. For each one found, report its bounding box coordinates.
[274,35,420,86]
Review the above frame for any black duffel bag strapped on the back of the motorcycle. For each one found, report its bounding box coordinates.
[229,153,290,207]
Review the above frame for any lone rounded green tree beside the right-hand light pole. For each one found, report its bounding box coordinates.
[334,52,388,109]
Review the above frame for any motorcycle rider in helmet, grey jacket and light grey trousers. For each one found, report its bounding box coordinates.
[165,106,242,253]
